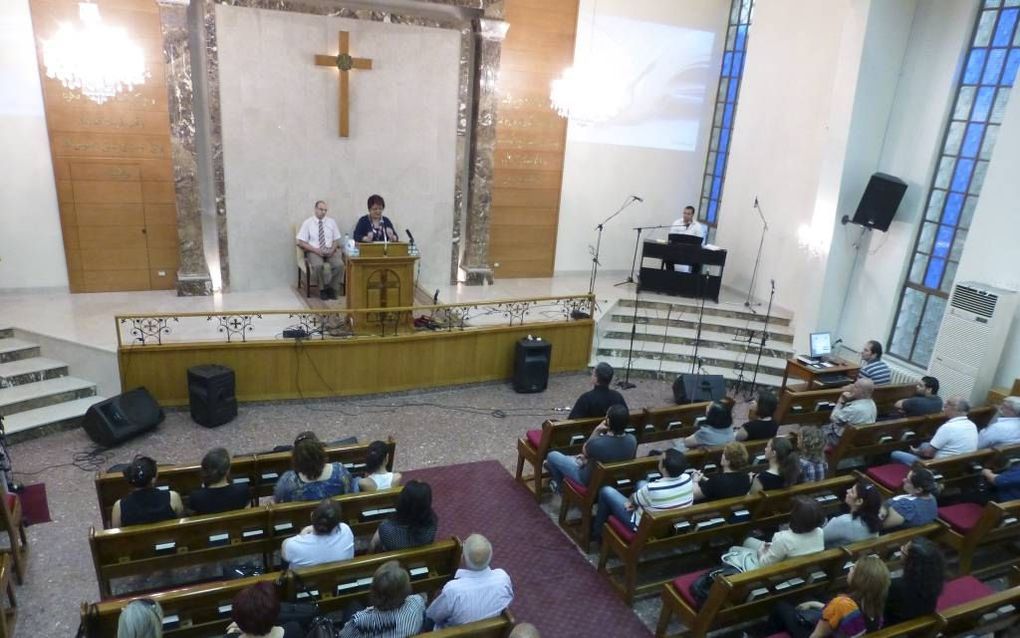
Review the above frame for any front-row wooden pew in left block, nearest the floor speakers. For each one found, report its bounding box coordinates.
[95,438,397,528]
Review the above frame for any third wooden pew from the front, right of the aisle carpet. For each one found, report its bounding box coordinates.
[599,495,762,604]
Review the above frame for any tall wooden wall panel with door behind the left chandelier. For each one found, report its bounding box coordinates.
[26,0,177,292]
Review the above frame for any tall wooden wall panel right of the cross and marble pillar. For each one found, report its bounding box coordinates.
[489,0,578,278]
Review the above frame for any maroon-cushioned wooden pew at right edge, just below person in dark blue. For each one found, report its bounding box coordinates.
[938,500,1020,575]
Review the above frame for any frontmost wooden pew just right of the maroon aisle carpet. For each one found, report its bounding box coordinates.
[515,402,708,501]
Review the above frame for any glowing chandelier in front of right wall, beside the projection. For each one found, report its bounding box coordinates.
[549,1,629,126]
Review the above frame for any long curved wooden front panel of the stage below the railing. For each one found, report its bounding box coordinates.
[117,320,595,405]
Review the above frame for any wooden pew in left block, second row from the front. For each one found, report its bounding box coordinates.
[89,488,400,599]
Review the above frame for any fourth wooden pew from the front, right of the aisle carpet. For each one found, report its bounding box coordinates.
[655,548,847,638]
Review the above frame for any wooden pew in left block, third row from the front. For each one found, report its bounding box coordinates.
[82,538,463,638]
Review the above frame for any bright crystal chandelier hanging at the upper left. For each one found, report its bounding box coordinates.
[43,2,147,104]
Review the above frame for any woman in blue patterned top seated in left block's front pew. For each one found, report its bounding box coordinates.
[272,432,358,503]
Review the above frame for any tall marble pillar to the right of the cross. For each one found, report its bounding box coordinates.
[460,12,510,285]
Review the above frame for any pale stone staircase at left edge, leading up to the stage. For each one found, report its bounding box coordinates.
[0,328,104,442]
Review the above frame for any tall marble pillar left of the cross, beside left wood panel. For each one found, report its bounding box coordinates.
[159,0,212,296]
